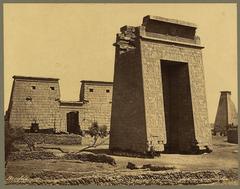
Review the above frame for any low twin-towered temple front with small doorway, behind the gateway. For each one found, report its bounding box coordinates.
[5,76,113,133]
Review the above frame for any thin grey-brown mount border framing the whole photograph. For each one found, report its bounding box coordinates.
[0,0,240,189]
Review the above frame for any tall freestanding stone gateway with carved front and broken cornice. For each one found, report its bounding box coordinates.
[109,16,211,153]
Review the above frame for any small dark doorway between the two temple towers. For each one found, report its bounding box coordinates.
[67,111,80,134]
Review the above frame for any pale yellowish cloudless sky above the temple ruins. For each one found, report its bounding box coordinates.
[4,3,237,122]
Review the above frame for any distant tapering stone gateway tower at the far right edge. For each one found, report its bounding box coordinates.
[214,91,238,134]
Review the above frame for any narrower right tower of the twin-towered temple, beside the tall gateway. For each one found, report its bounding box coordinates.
[79,80,113,130]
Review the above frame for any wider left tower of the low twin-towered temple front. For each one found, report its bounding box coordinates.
[7,76,60,129]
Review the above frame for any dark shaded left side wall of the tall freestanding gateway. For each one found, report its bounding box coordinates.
[110,27,147,152]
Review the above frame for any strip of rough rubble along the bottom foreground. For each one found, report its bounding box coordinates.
[6,170,238,185]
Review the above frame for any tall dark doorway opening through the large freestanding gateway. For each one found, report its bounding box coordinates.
[161,60,195,153]
